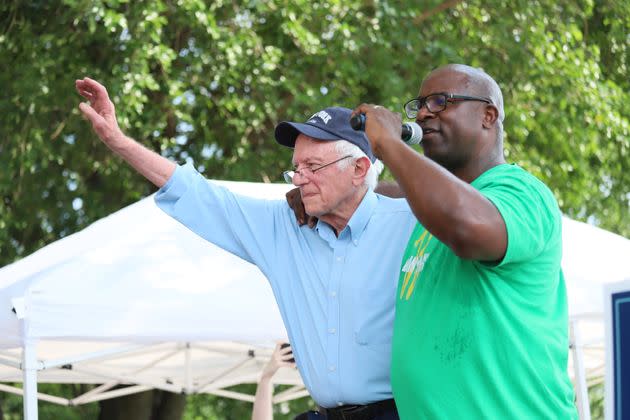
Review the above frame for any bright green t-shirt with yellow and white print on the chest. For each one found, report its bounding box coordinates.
[391,164,577,420]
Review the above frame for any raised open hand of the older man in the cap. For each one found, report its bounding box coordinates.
[75,77,123,144]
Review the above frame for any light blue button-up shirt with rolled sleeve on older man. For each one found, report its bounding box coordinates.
[155,165,416,407]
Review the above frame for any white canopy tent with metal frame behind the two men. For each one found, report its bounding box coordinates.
[0,182,630,419]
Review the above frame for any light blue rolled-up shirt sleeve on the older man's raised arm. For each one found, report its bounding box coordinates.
[155,164,286,271]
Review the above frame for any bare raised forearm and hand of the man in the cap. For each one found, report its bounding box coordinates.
[75,77,177,187]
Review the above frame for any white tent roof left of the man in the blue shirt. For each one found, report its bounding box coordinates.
[0,182,288,347]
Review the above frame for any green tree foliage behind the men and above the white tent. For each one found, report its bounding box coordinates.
[0,0,630,416]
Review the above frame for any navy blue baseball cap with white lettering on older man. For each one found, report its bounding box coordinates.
[275,106,376,162]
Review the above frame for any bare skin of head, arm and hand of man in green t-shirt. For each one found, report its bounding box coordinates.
[354,66,507,261]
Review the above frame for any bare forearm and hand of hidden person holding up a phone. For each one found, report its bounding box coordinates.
[252,343,295,420]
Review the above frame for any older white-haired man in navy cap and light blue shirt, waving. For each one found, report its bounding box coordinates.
[76,78,415,420]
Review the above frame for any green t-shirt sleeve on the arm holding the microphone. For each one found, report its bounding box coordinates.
[480,174,561,266]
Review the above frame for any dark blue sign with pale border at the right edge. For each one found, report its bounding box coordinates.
[611,291,630,420]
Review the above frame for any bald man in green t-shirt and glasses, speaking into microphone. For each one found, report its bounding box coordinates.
[355,65,577,420]
